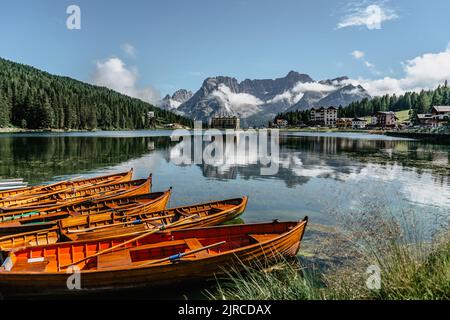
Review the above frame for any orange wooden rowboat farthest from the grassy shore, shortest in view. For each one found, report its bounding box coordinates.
[0,169,133,200]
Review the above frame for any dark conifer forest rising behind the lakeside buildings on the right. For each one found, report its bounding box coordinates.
[275,83,450,125]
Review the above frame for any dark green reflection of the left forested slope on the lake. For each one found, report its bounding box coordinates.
[0,136,170,183]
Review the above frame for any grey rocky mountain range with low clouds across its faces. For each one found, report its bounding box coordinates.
[160,71,370,126]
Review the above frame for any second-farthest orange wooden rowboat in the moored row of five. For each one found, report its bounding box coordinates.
[0,175,152,212]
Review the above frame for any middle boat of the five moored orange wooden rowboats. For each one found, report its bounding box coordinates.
[0,186,163,236]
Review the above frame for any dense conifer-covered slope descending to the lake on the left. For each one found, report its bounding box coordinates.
[0,58,192,130]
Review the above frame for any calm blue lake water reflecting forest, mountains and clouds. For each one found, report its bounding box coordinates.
[0,131,450,230]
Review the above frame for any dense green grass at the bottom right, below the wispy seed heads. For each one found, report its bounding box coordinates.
[210,235,450,300]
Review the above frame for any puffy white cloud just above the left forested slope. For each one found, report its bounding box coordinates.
[93,58,160,104]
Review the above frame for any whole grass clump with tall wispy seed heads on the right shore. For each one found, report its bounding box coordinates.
[210,205,450,300]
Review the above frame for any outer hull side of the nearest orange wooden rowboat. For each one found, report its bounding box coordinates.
[0,219,307,296]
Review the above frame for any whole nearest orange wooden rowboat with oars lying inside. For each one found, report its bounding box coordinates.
[0,218,308,296]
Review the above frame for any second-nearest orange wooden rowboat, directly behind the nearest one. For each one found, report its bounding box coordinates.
[0,195,248,251]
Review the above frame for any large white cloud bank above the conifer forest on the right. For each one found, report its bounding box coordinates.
[348,43,450,96]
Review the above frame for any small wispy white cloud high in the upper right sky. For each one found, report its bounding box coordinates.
[337,4,398,30]
